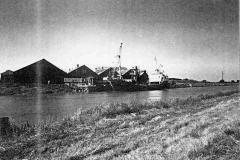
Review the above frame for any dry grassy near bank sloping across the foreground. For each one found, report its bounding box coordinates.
[0,91,240,160]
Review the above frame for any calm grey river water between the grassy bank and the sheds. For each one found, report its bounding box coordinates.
[0,85,238,124]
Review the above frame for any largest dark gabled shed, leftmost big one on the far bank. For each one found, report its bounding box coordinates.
[13,59,67,84]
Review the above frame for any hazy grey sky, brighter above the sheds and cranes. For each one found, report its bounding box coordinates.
[0,0,240,81]
